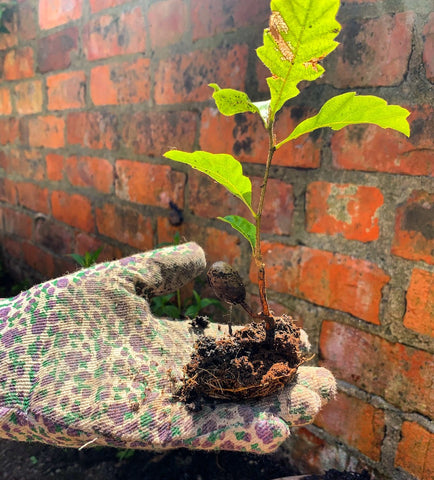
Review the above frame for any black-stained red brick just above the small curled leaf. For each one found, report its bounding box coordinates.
[155,45,248,104]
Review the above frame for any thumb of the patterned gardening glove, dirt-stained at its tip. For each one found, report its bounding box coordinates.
[102,242,206,298]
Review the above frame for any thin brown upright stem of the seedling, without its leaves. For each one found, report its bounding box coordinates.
[254,120,276,324]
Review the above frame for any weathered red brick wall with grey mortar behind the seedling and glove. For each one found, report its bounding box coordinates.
[0,0,434,480]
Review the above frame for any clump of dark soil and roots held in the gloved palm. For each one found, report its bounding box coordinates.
[180,315,305,403]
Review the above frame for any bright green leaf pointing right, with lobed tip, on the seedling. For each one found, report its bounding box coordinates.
[276,92,410,148]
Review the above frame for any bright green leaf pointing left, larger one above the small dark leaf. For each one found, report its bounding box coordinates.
[164,150,255,215]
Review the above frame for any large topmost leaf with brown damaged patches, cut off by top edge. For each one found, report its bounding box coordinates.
[256,0,341,119]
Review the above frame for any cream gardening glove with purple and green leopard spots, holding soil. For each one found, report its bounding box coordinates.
[0,243,335,453]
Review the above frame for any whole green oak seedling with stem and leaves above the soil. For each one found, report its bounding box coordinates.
[165,0,410,338]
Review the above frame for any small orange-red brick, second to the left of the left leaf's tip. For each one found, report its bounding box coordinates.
[65,156,114,193]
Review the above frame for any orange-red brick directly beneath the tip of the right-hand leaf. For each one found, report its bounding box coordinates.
[331,105,434,175]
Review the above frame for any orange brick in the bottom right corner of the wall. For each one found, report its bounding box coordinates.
[395,421,434,480]
